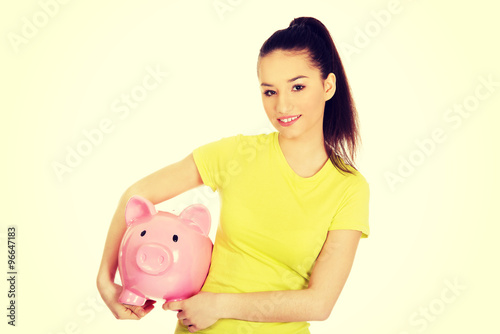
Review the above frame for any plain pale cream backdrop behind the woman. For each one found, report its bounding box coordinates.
[0,0,500,334]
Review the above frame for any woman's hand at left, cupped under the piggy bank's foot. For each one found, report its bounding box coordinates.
[98,282,156,320]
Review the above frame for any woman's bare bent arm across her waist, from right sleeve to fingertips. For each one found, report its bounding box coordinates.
[164,230,361,331]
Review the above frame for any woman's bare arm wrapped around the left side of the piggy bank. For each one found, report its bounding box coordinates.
[97,154,203,319]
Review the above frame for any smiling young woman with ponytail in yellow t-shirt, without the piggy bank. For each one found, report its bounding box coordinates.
[97,17,369,334]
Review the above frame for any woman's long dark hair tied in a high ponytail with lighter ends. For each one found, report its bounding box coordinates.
[259,17,360,174]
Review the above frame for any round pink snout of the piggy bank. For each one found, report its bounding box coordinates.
[136,244,172,275]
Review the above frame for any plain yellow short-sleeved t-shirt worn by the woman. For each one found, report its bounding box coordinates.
[176,132,369,334]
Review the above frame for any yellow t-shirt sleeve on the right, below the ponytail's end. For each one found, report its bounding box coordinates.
[328,173,370,238]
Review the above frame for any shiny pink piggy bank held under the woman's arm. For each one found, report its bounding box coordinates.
[118,196,213,305]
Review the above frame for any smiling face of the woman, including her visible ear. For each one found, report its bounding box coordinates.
[258,50,335,139]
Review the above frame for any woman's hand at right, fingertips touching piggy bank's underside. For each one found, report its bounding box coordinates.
[163,292,219,333]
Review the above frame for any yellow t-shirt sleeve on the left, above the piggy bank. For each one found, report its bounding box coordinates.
[193,135,241,191]
